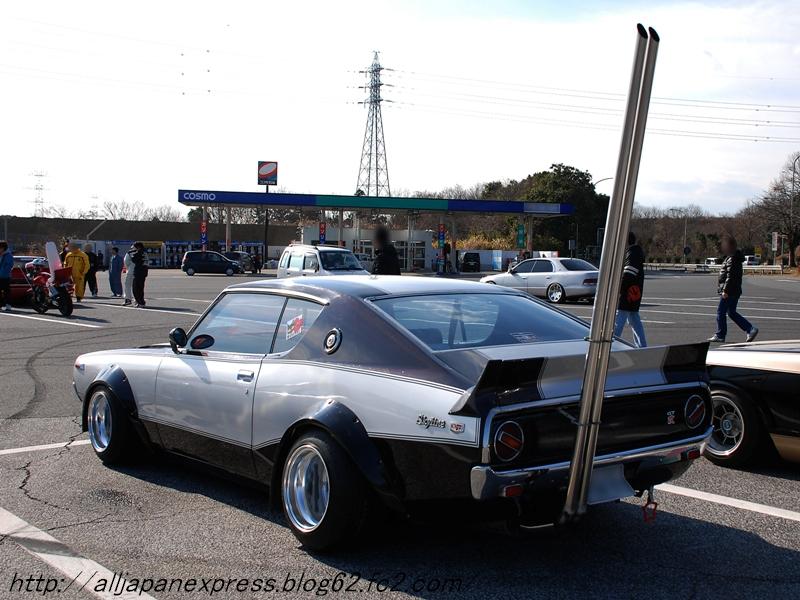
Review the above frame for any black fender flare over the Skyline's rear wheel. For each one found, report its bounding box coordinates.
[270,400,405,511]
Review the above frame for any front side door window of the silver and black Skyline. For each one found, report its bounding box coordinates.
[189,293,286,354]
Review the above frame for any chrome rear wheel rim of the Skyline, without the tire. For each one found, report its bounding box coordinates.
[283,444,330,532]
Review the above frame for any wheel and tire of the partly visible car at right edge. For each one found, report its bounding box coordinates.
[704,387,764,468]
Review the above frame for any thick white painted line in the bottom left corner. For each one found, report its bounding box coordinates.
[0,507,155,600]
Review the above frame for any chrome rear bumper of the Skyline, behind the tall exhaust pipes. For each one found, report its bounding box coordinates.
[470,427,712,500]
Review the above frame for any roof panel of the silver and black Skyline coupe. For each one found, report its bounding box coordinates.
[225,275,525,299]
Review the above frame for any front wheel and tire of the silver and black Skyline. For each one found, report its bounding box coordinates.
[86,385,138,465]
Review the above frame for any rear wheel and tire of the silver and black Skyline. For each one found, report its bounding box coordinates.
[281,431,371,551]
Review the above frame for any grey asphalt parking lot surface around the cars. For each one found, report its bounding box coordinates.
[0,272,800,598]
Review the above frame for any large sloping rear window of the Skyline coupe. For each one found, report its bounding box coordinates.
[374,294,588,350]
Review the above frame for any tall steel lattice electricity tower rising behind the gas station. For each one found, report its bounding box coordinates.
[356,51,392,196]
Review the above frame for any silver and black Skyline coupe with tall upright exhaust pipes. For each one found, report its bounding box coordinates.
[74,276,711,549]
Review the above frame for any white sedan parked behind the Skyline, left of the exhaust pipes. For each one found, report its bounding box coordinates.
[481,258,597,303]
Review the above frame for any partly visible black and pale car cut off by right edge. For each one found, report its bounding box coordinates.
[705,340,800,467]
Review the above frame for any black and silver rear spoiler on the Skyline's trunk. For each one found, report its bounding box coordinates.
[450,342,709,417]
